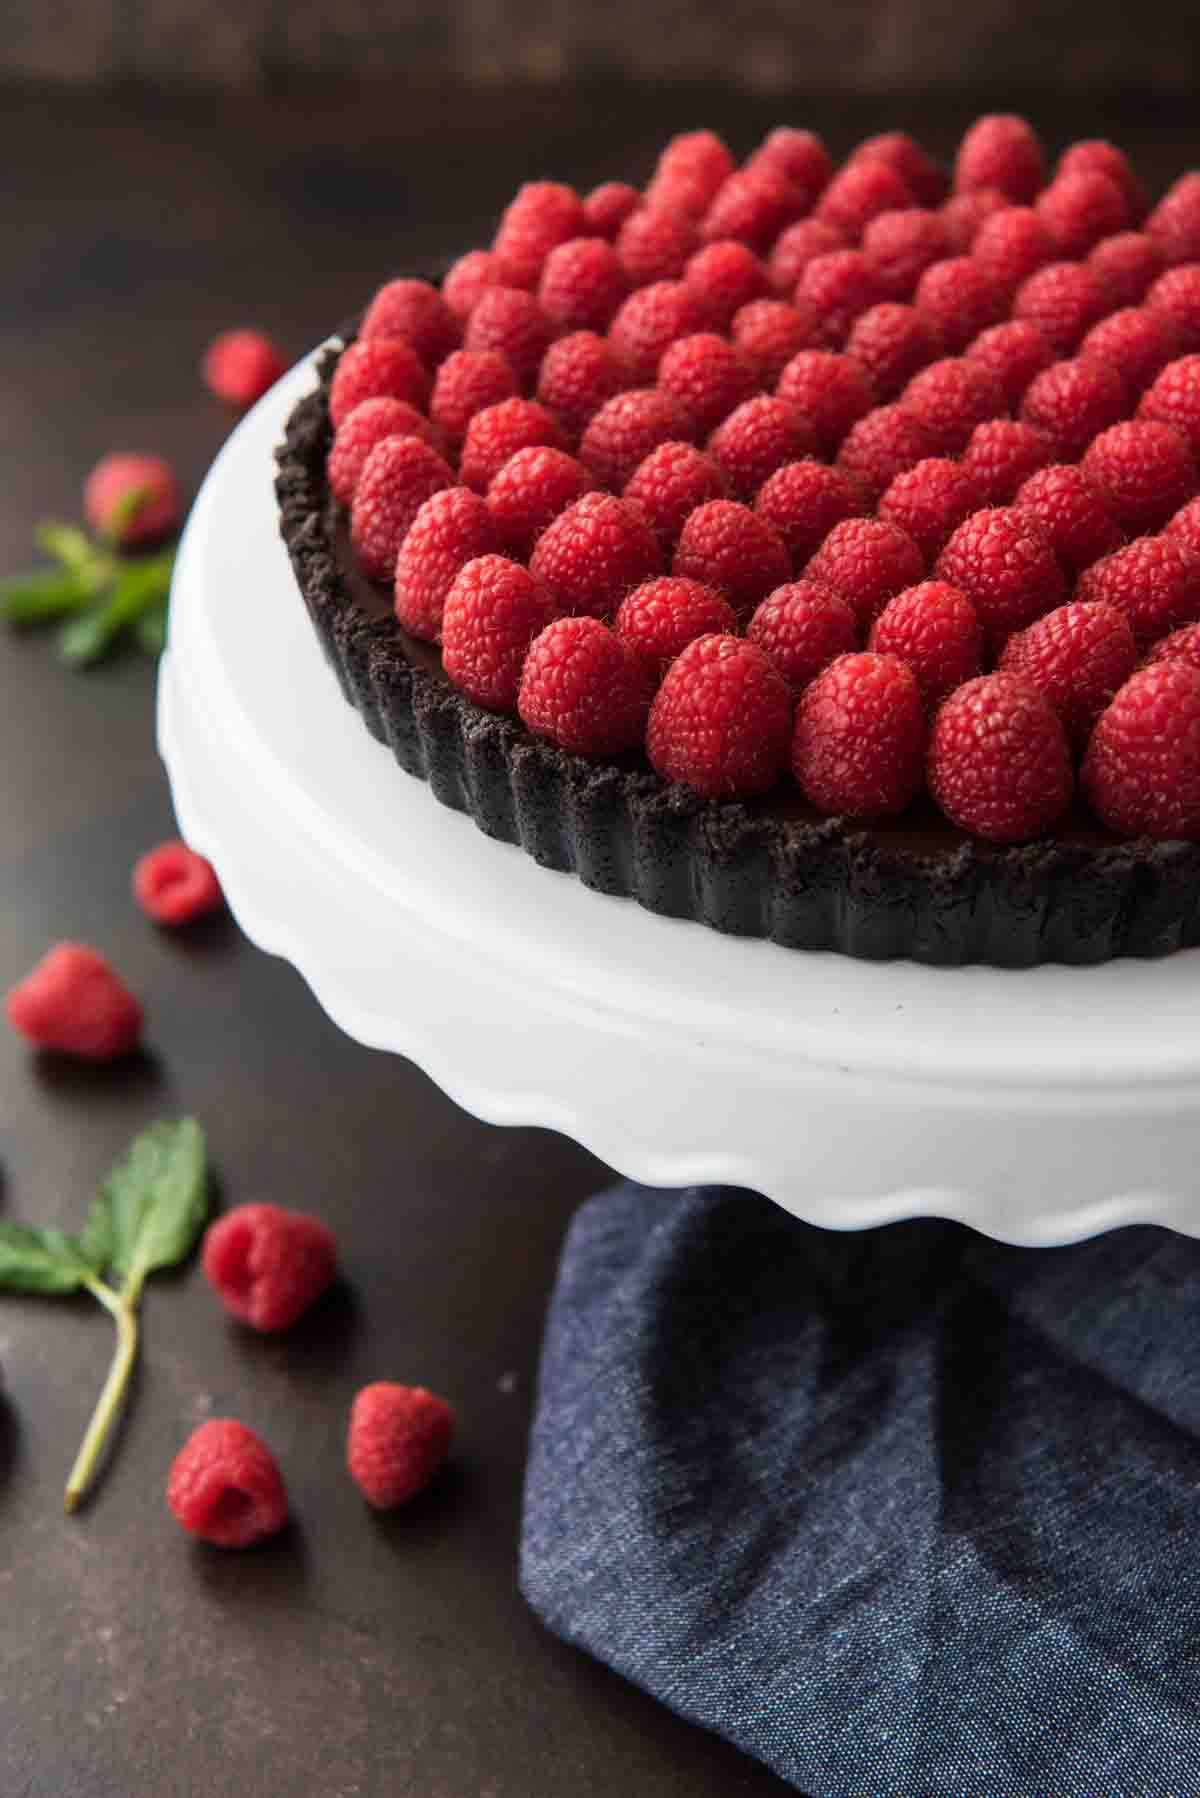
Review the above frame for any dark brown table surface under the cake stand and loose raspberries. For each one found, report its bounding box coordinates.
[0,86,1193,1798]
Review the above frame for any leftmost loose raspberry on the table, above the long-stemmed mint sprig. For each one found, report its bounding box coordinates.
[5,942,142,1061]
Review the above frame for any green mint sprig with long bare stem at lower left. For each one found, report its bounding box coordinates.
[0,1118,209,1512]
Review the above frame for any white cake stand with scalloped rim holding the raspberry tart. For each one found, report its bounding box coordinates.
[158,361,1200,1244]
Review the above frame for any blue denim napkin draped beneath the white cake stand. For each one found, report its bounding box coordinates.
[522,1185,1200,1798]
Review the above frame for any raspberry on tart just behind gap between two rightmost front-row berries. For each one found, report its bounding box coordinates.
[1000,601,1137,753]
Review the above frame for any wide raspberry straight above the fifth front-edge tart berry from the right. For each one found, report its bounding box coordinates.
[529,493,662,619]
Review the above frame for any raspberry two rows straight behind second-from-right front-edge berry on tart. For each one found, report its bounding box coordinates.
[934,505,1067,649]
